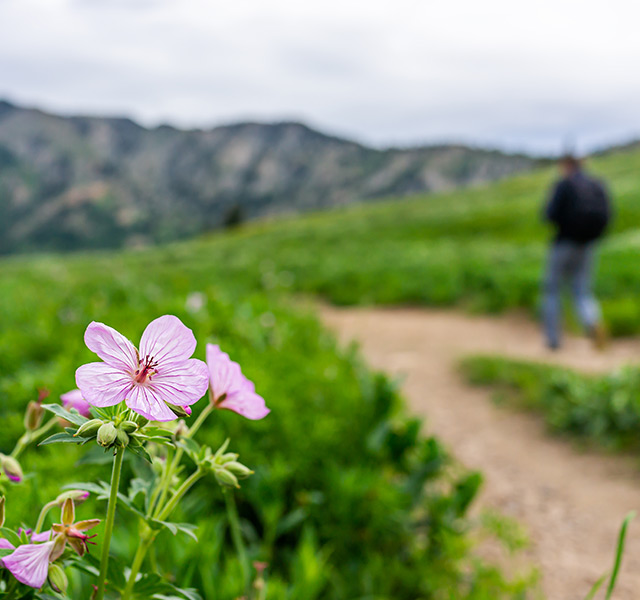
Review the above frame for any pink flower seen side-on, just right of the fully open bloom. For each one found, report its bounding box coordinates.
[207,344,270,420]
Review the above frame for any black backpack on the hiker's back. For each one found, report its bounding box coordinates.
[562,173,611,243]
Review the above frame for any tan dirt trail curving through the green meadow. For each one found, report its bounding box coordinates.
[322,308,640,600]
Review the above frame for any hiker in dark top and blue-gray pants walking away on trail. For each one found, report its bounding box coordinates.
[542,155,611,350]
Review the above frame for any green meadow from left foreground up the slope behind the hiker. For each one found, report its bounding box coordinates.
[0,144,640,600]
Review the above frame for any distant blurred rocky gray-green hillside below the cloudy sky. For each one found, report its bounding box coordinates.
[0,101,536,253]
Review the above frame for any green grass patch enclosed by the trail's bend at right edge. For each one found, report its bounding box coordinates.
[461,356,640,452]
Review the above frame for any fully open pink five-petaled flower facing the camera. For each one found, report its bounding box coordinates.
[76,315,208,421]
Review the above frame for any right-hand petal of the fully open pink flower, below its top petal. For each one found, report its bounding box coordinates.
[149,358,209,406]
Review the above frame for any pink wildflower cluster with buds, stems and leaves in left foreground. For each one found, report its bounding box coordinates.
[0,315,269,600]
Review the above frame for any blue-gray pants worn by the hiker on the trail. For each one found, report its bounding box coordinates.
[542,241,600,348]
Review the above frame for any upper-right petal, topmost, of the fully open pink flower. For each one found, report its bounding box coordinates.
[140,315,196,366]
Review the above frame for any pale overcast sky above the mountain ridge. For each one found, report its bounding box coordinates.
[0,0,640,152]
